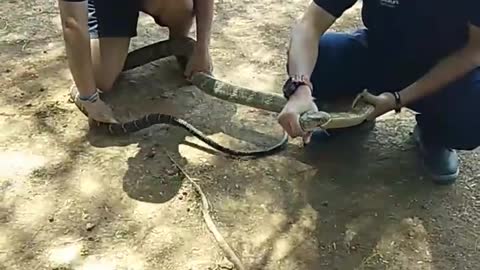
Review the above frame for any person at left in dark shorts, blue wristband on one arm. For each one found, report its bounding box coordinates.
[58,0,214,123]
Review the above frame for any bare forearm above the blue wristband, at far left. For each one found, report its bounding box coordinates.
[58,0,96,96]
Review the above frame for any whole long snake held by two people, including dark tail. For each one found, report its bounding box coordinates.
[70,37,374,156]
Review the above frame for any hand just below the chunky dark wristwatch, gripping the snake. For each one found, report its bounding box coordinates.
[278,85,318,144]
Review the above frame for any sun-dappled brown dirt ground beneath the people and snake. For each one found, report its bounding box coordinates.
[0,0,480,270]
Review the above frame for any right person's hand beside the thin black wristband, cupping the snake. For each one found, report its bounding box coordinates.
[353,90,396,121]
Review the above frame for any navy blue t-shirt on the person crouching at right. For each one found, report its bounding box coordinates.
[314,0,480,65]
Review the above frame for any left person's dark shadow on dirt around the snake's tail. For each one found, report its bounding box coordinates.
[88,57,281,203]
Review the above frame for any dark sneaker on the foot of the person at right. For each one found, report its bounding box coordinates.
[413,125,460,185]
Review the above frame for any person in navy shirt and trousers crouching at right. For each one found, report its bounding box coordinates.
[278,0,480,184]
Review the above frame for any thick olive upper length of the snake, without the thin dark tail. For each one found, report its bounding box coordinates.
[124,37,375,131]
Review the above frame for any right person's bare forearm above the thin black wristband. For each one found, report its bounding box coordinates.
[399,25,480,106]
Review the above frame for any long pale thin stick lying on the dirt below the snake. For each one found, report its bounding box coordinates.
[165,150,245,270]
